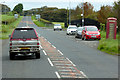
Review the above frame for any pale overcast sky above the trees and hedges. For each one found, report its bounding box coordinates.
[0,0,118,11]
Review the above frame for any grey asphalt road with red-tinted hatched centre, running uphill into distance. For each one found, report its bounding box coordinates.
[2,16,118,78]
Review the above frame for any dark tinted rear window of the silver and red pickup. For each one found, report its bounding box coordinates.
[12,28,37,39]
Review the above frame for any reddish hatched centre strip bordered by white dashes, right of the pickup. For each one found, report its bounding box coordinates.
[40,37,87,78]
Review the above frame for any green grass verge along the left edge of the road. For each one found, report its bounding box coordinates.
[0,16,23,39]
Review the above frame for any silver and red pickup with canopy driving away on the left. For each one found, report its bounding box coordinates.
[9,27,40,60]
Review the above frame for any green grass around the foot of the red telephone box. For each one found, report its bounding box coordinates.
[98,31,120,55]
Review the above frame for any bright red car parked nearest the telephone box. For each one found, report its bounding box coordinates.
[82,26,101,40]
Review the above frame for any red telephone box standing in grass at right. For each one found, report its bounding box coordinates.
[106,18,117,39]
